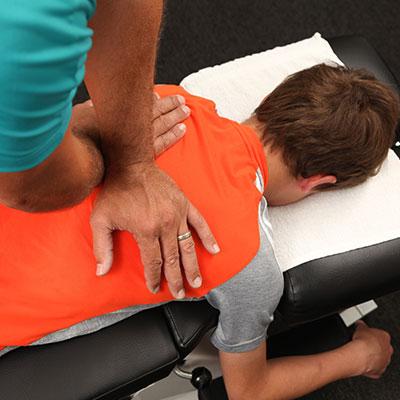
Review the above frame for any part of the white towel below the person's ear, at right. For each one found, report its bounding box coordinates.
[269,150,400,271]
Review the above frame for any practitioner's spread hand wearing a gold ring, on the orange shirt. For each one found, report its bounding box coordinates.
[91,163,219,298]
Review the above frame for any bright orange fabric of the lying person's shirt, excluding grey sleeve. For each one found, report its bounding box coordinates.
[0,86,267,348]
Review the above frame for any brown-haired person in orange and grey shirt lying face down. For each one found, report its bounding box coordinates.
[0,65,399,400]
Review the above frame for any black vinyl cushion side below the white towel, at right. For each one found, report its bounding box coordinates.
[278,239,400,326]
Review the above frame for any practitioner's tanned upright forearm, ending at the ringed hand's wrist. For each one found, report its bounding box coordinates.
[85,0,162,174]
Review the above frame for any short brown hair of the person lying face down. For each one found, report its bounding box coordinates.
[255,64,400,190]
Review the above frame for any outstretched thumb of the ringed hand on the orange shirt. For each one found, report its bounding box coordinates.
[91,223,113,276]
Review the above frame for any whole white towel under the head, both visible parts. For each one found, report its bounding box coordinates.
[181,33,400,271]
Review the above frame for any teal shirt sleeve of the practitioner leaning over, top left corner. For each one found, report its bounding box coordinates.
[0,0,96,172]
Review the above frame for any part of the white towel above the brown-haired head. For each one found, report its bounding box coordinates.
[181,33,343,122]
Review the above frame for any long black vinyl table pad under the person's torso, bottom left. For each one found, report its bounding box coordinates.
[0,308,179,400]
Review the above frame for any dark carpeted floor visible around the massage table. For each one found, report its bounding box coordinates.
[157,0,400,400]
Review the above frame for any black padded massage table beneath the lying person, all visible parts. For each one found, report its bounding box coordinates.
[0,36,400,400]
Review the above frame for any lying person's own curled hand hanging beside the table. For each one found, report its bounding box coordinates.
[353,321,393,379]
